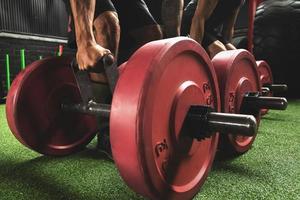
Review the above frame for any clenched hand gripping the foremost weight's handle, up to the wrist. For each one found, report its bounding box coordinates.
[76,42,110,70]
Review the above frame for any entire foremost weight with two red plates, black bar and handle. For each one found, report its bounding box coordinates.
[6,37,257,199]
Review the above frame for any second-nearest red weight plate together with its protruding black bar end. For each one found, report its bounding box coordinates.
[212,50,287,156]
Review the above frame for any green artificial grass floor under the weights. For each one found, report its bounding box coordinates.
[0,100,300,200]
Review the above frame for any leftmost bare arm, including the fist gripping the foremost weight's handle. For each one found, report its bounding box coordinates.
[70,0,110,69]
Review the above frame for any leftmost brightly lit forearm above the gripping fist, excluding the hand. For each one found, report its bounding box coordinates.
[70,0,96,46]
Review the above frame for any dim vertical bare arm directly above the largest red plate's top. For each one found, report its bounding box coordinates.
[161,0,183,38]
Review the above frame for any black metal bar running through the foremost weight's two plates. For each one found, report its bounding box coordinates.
[61,101,257,139]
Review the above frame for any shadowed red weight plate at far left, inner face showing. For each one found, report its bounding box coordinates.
[6,57,97,155]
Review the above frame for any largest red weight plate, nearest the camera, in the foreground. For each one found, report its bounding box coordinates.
[110,38,219,199]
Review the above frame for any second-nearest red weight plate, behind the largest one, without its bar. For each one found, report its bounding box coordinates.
[212,50,261,154]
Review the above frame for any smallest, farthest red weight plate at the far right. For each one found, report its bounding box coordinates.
[256,60,273,115]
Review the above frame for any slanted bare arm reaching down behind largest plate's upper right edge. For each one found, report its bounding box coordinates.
[190,0,219,44]
